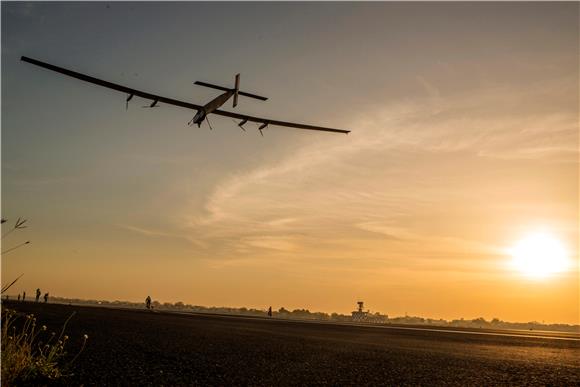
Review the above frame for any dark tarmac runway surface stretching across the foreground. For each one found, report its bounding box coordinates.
[3,302,580,386]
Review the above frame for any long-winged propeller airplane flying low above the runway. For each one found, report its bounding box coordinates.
[20,56,350,136]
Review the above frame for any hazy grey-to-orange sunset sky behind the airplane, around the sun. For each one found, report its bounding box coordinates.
[1,2,580,324]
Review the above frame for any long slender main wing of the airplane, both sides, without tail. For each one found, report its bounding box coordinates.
[20,56,350,133]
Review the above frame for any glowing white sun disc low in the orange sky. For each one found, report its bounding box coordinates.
[509,233,569,279]
